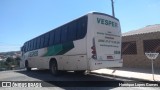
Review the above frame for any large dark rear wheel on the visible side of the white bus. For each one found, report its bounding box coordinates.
[50,61,58,76]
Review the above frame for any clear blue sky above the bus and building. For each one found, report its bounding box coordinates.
[0,0,160,52]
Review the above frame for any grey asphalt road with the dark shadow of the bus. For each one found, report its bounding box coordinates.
[0,70,160,90]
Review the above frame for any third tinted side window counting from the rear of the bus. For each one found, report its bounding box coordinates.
[61,25,68,43]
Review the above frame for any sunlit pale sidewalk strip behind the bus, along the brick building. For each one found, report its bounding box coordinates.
[91,67,160,81]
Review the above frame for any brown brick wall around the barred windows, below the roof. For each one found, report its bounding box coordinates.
[122,32,160,68]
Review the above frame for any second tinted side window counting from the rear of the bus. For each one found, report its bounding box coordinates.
[67,21,77,41]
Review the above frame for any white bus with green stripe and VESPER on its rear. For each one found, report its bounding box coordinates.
[21,12,123,75]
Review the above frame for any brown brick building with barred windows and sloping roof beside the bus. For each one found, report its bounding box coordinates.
[122,24,160,68]
